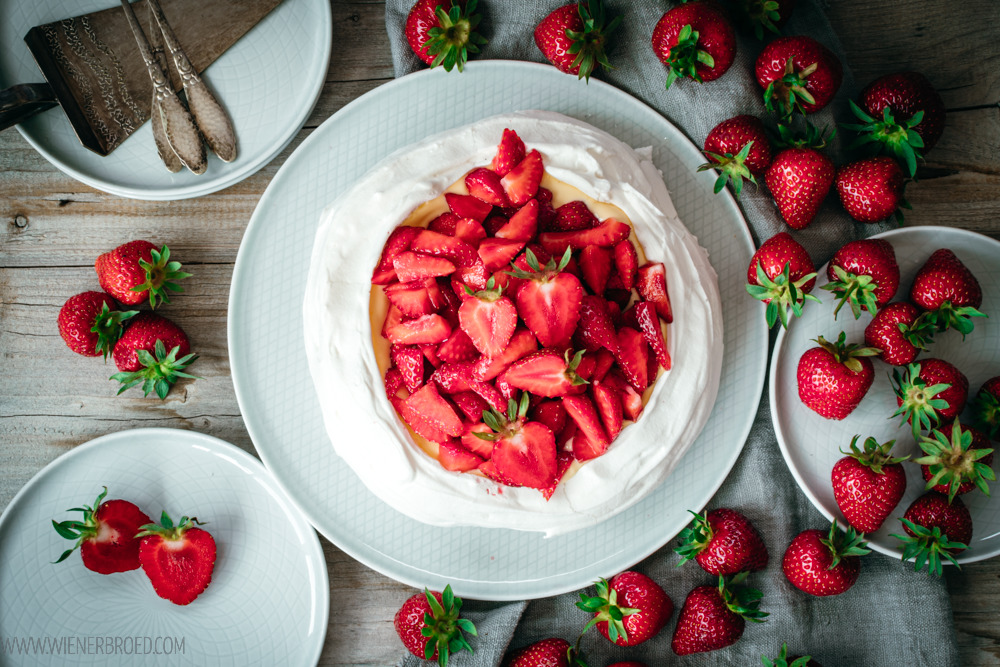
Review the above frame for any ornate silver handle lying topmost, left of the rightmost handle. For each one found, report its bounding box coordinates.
[121,0,208,174]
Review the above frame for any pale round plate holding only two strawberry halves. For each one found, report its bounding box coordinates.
[0,428,330,667]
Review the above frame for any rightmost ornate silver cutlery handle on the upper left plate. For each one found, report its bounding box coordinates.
[146,0,236,162]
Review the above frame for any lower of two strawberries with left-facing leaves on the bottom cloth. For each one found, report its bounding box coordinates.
[576,571,674,646]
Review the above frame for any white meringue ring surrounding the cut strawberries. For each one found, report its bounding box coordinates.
[303,111,722,536]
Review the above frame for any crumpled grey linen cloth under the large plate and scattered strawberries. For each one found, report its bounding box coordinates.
[386,0,958,667]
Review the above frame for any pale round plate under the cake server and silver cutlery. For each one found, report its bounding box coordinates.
[0,0,332,200]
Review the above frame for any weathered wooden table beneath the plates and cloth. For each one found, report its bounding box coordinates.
[0,0,1000,665]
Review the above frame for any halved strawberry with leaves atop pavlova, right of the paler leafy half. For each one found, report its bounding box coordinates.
[511,248,583,348]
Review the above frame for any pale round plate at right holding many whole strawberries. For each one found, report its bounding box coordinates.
[770,227,1000,563]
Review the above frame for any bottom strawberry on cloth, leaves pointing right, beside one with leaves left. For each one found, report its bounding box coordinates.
[670,572,767,655]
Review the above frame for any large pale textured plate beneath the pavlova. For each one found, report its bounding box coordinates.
[229,61,767,600]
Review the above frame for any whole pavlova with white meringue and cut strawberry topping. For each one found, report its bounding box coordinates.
[303,111,722,535]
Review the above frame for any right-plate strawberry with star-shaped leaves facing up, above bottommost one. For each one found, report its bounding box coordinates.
[914,419,997,502]
